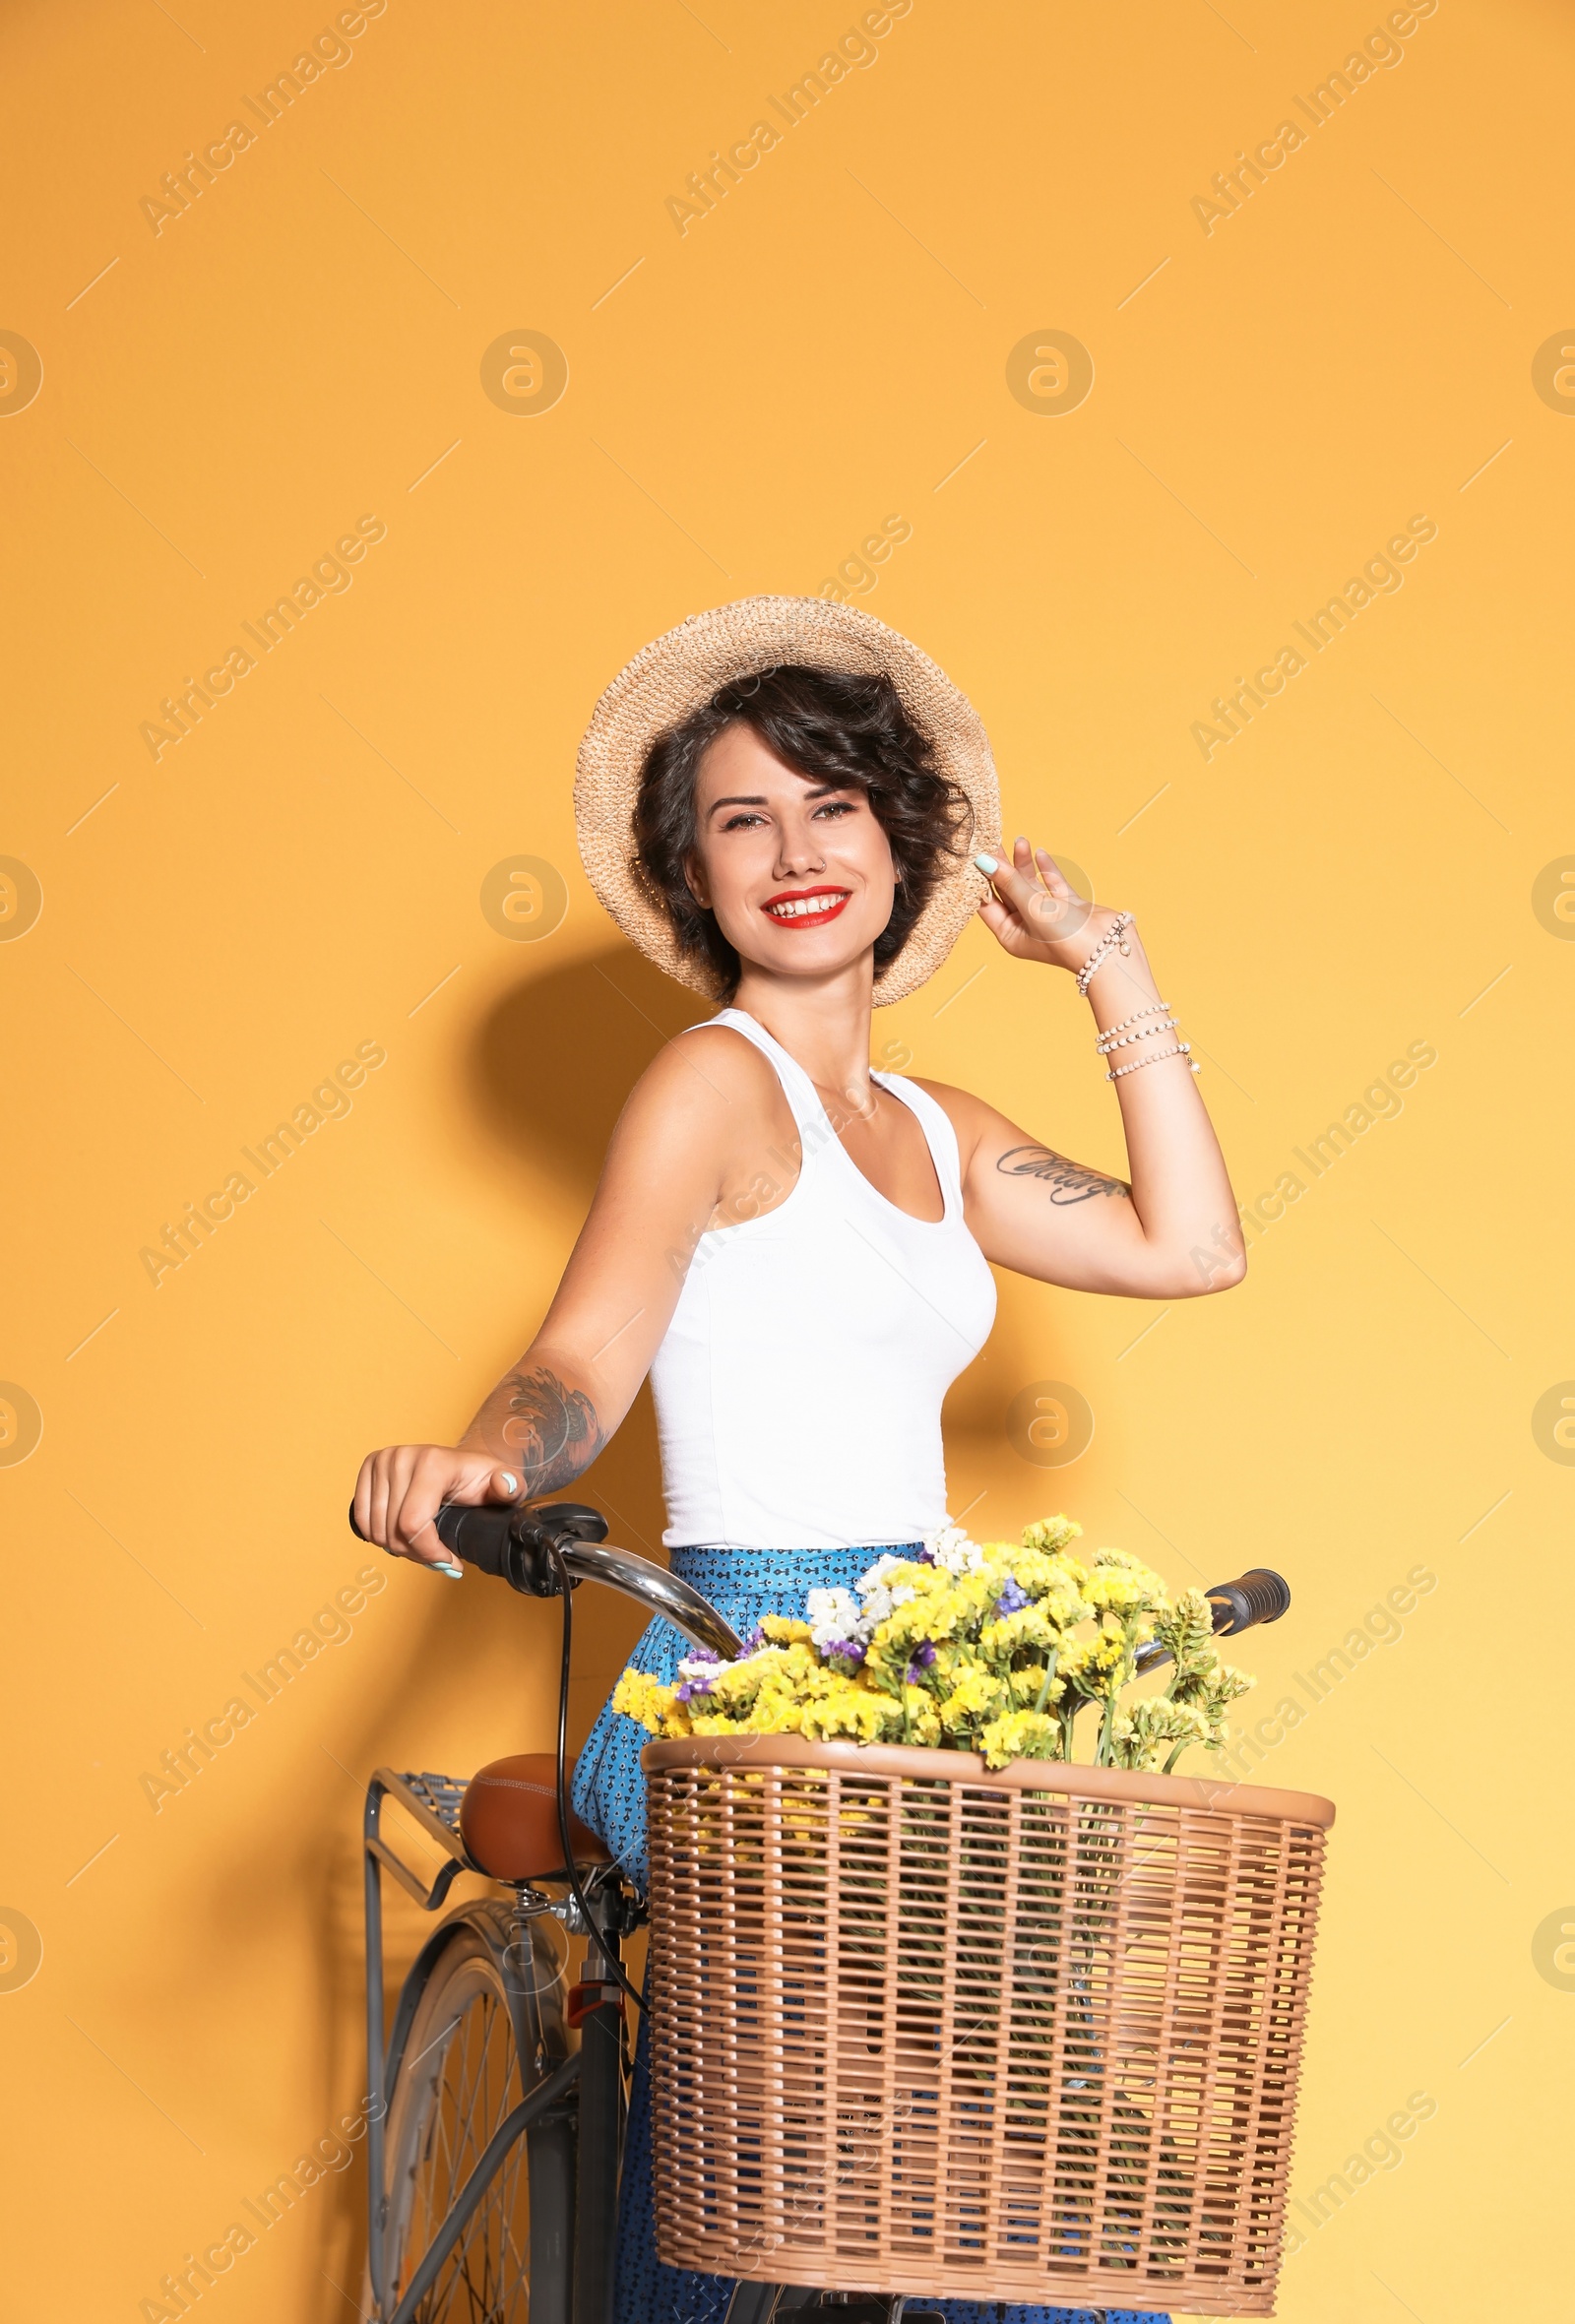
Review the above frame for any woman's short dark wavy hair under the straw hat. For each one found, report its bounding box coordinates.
[630,664,974,999]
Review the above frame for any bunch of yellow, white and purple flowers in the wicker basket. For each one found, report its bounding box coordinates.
[613,1518,1252,1773]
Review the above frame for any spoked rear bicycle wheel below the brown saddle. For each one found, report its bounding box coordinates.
[381,1906,574,2324]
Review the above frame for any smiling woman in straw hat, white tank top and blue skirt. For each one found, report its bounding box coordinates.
[355,597,1245,2324]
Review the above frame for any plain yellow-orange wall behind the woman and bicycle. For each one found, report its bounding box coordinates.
[0,0,1575,2324]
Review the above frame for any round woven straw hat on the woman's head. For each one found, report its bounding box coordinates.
[574,597,1001,1002]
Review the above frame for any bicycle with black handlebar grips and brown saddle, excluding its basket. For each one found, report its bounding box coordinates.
[350,1501,1290,2324]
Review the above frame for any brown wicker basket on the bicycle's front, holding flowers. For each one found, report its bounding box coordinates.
[644,1736,1334,2315]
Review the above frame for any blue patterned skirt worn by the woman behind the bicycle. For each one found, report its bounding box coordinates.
[574,1543,1166,2324]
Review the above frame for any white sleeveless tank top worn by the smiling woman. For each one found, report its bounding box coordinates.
[651,1009,994,1550]
